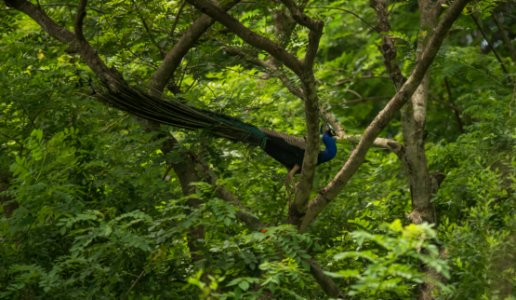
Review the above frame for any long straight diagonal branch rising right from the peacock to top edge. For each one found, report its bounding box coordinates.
[300,0,470,231]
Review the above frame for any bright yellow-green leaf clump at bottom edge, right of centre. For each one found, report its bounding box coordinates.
[332,220,450,299]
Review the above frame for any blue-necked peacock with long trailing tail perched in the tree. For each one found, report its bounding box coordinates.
[99,87,337,178]
